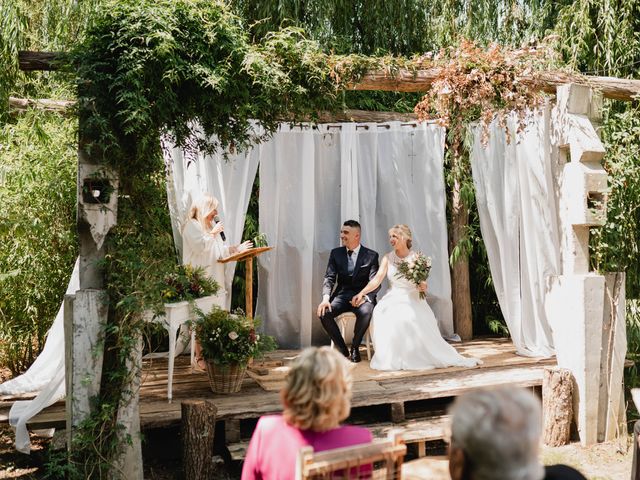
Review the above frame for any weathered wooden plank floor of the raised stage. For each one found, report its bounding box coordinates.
[0,339,555,429]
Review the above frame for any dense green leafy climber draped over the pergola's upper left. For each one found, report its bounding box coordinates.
[71,0,350,172]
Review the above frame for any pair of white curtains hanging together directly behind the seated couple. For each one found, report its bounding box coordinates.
[257,122,453,348]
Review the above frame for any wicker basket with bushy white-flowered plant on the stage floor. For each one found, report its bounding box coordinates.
[195,306,276,393]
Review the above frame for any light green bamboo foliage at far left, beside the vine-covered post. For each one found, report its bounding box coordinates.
[0,111,77,374]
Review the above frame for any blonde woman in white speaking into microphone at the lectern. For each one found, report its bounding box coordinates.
[182,194,253,371]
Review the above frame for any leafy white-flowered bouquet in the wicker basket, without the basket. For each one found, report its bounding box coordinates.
[194,306,276,365]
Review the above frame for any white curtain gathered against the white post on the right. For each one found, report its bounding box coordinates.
[471,109,560,357]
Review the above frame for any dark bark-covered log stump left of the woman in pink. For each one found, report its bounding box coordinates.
[181,400,218,480]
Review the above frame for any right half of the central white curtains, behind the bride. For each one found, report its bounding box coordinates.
[357,122,453,337]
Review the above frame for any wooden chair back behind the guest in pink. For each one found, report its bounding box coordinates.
[296,431,407,480]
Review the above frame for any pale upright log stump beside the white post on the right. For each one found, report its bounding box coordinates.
[542,367,573,447]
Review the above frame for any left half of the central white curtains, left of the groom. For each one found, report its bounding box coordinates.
[257,124,341,348]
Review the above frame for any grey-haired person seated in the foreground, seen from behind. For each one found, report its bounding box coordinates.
[449,387,586,480]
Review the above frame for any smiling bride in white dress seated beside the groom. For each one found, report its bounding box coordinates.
[352,225,482,370]
